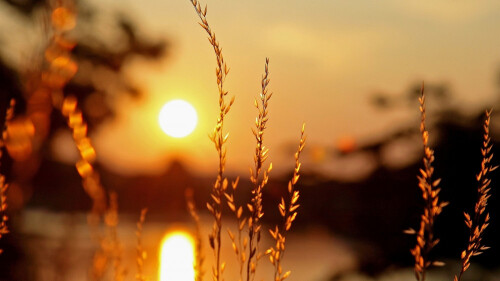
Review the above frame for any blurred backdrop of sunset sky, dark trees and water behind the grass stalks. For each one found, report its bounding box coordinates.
[0,0,500,281]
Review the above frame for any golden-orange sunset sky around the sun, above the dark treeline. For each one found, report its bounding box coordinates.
[0,0,500,175]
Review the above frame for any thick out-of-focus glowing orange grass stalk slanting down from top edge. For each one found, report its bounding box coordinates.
[45,1,107,215]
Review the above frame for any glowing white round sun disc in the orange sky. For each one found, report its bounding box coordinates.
[158,100,198,138]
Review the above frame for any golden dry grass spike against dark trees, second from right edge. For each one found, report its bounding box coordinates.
[406,83,448,281]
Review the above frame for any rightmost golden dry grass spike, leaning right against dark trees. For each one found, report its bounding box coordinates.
[454,110,498,281]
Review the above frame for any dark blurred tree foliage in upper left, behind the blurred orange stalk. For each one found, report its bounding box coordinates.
[0,0,169,133]
